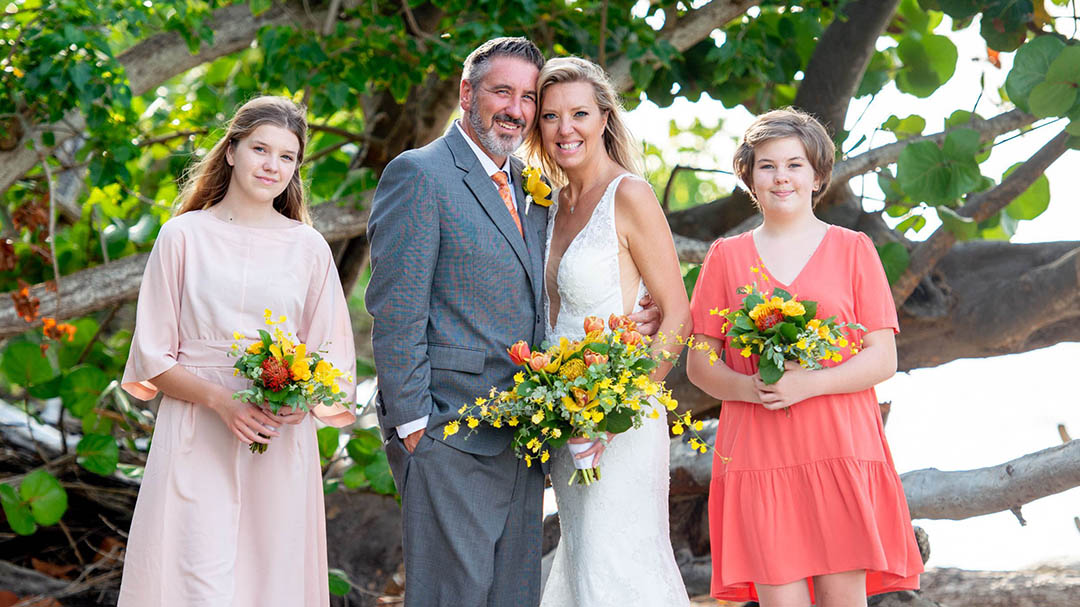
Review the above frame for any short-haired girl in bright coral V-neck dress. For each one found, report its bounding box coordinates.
[687,109,922,607]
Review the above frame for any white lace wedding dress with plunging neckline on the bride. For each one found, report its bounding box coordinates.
[540,174,689,607]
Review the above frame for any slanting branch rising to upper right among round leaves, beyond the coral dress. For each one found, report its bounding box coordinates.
[892,132,1069,308]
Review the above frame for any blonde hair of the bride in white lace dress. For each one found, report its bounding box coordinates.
[525,57,642,186]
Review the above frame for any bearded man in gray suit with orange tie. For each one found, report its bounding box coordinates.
[366,38,658,607]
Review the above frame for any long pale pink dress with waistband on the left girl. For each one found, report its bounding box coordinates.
[119,211,355,607]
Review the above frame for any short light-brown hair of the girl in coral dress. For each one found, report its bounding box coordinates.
[732,108,836,205]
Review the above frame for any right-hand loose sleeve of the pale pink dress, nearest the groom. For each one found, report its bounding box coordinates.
[297,235,356,428]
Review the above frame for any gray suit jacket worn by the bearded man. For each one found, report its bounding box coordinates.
[366,125,548,455]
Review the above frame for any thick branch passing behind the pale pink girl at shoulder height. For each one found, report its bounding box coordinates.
[0,203,367,338]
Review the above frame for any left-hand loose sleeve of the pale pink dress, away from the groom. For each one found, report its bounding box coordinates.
[121,221,185,401]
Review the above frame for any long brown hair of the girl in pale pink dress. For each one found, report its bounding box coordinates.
[176,96,311,226]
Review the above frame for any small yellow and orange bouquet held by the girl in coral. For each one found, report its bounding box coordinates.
[708,267,866,383]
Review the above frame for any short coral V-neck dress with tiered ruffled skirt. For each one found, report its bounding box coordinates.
[690,226,922,601]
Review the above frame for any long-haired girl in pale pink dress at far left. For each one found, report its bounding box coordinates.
[119,97,355,607]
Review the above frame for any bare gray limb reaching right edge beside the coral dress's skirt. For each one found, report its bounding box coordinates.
[901,441,1080,521]
